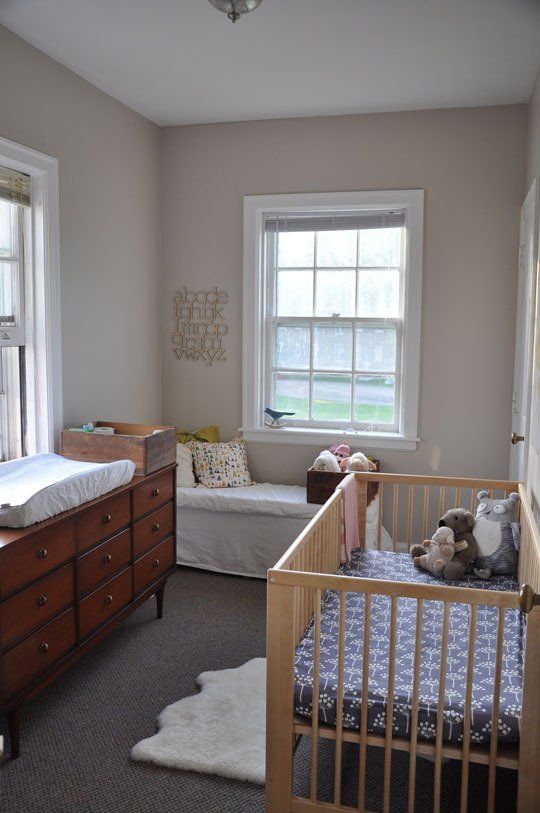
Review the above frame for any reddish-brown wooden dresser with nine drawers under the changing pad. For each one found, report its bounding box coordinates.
[0,465,176,757]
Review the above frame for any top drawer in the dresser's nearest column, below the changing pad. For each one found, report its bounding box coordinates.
[0,518,75,596]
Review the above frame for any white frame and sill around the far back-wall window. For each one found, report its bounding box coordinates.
[242,189,424,451]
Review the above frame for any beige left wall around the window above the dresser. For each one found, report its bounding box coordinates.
[0,27,161,424]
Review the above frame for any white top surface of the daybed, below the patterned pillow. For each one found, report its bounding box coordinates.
[176,483,321,519]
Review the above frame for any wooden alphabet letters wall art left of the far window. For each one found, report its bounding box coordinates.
[172,285,229,367]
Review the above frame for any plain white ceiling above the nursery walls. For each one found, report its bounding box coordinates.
[0,0,540,124]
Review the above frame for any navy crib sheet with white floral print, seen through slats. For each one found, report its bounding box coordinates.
[294,550,525,743]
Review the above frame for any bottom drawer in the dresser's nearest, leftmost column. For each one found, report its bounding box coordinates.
[3,608,77,697]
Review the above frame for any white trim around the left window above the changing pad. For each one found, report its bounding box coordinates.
[0,133,63,454]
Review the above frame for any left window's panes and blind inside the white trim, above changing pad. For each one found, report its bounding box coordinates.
[0,166,31,461]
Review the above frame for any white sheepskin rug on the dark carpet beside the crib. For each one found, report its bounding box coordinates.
[131,658,266,785]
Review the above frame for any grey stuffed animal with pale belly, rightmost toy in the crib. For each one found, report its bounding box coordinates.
[473,491,519,579]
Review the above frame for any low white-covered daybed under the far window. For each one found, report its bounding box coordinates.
[176,483,391,579]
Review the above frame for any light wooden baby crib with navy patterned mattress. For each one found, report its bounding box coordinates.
[266,473,540,813]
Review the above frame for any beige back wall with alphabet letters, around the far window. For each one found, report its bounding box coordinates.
[162,105,527,483]
